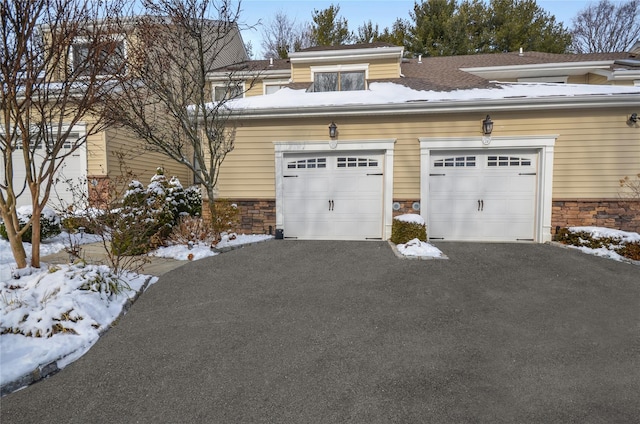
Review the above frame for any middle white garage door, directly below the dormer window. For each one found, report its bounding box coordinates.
[283,152,383,240]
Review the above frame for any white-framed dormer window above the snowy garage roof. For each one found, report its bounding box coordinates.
[311,64,368,92]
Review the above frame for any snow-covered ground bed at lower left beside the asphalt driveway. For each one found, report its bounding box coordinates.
[0,264,157,385]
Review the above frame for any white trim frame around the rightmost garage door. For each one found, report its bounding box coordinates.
[419,134,558,243]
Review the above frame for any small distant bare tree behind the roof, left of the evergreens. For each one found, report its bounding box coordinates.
[262,11,311,59]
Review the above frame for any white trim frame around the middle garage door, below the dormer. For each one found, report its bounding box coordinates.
[273,138,396,240]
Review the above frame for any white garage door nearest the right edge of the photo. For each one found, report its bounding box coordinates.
[427,150,537,241]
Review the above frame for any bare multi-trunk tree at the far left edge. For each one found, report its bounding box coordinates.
[0,0,123,268]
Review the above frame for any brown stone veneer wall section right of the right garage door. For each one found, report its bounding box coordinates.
[551,199,640,232]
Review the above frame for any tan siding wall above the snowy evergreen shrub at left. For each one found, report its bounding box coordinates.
[106,128,193,187]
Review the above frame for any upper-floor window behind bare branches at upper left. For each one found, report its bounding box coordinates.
[71,35,126,75]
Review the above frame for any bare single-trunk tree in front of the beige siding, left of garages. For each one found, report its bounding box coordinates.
[109,0,251,235]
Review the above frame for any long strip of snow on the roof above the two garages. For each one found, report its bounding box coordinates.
[226,82,640,110]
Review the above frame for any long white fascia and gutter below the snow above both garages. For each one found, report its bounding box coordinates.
[230,94,638,119]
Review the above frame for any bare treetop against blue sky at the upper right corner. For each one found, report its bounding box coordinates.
[572,0,640,53]
